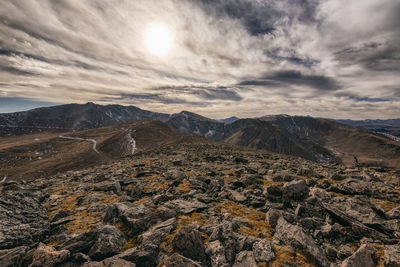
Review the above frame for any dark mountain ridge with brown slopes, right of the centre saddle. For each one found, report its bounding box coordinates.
[167,113,400,167]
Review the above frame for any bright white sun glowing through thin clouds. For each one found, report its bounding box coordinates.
[146,24,173,57]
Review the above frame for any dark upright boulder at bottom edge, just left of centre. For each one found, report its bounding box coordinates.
[172,226,207,263]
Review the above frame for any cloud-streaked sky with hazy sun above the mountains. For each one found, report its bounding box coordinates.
[0,0,400,119]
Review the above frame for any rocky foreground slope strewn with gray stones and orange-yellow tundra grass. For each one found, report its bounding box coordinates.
[0,137,400,267]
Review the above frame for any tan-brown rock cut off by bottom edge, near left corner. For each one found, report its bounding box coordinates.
[30,243,70,267]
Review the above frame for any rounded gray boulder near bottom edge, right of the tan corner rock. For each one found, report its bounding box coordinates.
[88,225,126,261]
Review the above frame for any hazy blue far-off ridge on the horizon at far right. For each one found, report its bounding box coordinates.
[336,119,400,137]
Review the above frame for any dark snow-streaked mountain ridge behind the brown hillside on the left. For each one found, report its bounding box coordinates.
[0,103,169,136]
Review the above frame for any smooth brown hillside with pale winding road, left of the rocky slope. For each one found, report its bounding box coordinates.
[0,121,182,180]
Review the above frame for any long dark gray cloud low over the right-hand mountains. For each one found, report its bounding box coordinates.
[240,70,340,91]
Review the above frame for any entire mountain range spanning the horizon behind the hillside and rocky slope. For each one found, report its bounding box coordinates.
[0,103,400,170]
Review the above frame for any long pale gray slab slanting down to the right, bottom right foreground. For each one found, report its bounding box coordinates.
[274,217,330,266]
